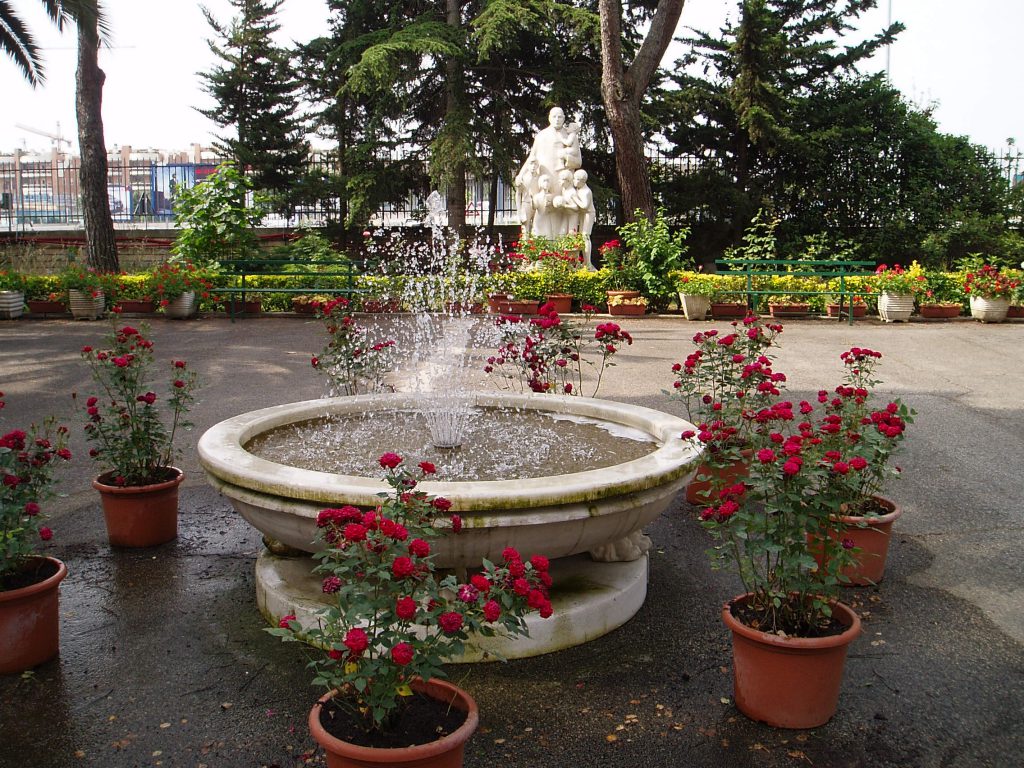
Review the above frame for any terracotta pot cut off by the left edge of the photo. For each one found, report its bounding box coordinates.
[0,557,68,675]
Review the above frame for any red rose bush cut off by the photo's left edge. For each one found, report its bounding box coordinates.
[0,392,71,591]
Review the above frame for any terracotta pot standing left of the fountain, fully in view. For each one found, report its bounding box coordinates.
[92,467,184,547]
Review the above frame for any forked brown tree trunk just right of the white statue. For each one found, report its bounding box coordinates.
[598,0,685,221]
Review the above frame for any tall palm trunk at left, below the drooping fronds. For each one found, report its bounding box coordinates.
[75,7,121,272]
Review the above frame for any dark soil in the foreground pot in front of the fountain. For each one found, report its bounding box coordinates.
[319,694,466,750]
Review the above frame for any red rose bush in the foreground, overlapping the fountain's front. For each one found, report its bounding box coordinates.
[267,454,551,732]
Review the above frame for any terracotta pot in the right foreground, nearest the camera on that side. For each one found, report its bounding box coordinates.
[722,595,860,728]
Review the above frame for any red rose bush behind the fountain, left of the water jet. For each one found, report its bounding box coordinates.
[310,298,394,395]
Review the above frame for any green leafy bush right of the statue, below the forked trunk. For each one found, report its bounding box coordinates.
[618,208,691,308]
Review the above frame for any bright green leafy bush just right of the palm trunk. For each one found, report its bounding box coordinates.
[171,163,263,266]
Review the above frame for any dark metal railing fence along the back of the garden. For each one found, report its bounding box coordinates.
[0,151,1024,231]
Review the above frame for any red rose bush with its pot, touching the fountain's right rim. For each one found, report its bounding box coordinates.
[667,314,782,504]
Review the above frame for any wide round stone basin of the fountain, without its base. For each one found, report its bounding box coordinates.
[199,392,700,568]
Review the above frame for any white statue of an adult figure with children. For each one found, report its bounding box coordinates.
[515,106,597,269]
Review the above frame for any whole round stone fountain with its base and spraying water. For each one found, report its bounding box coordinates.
[199,111,699,662]
